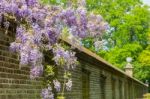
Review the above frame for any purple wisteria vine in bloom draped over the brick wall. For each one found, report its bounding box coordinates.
[0,0,108,99]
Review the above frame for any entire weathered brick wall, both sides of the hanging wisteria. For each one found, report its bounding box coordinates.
[0,31,147,99]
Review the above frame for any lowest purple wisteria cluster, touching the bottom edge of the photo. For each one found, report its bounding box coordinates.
[41,85,54,99]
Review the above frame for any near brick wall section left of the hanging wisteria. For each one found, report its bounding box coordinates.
[0,31,42,99]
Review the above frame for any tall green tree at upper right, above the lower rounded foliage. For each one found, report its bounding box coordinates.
[87,0,150,47]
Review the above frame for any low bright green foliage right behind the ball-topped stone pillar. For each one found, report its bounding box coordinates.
[99,43,142,69]
